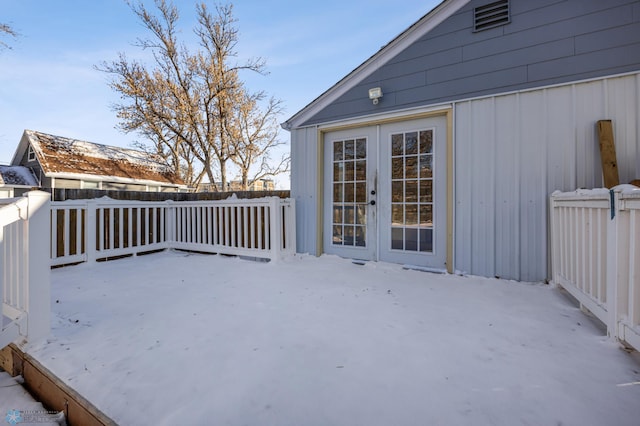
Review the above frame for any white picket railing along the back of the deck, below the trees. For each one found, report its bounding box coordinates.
[51,197,296,266]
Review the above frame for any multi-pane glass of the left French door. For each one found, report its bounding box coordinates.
[332,138,368,247]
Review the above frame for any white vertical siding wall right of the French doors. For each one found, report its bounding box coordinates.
[454,74,640,281]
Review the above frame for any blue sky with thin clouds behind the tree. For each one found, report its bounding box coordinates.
[0,0,440,186]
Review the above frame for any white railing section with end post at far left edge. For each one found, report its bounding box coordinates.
[0,191,51,349]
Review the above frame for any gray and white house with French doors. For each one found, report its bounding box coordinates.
[283,0,640,281]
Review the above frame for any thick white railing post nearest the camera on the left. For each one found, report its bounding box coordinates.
[26,191,51,340]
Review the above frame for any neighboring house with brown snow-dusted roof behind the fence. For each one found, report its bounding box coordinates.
[12,130,187,192]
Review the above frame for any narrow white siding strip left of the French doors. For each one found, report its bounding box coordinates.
[291,126,320,254]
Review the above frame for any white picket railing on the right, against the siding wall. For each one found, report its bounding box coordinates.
[550,185,640,350]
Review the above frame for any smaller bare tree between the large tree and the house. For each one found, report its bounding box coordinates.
[228,91,290,191]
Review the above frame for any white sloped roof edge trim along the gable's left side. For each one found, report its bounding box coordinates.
[281,0,462,130]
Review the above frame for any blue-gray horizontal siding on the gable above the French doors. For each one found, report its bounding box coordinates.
[304,0,640,125]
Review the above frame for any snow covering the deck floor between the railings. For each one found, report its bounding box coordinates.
[29,252,640,425]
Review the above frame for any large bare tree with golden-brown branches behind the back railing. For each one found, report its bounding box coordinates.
[97,0,264,187]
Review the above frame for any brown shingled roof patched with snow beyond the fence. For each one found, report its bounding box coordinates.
[24,130,184,185]
